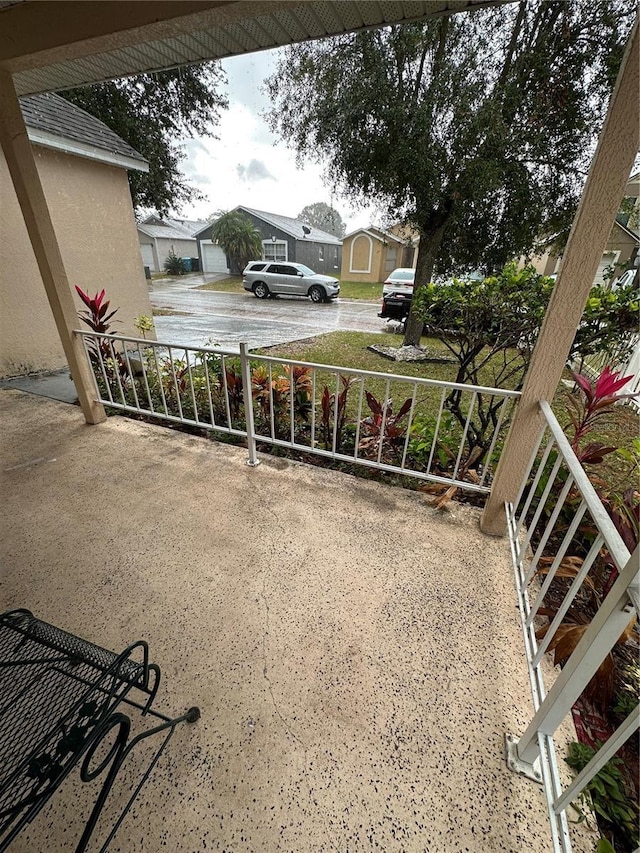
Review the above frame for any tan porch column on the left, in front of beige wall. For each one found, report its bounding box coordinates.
[0,69,106,424]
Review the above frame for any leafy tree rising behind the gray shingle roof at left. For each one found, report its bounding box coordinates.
[60,62,227,215]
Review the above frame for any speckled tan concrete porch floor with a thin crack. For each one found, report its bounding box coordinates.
[0,391,588,853]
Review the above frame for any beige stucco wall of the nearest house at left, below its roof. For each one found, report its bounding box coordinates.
[0,146,151,376]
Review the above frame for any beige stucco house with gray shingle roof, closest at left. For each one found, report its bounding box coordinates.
[0,89,152,376]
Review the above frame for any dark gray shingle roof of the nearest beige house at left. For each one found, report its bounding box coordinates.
[20,94,147,163]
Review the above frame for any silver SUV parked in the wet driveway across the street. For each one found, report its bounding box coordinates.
[242,261,340,302]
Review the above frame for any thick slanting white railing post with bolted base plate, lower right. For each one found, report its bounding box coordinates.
[515,546,640,765]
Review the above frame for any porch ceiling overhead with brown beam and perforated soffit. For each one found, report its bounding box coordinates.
[0,0,512,95]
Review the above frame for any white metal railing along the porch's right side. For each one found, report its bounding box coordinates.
[506,401,640,853]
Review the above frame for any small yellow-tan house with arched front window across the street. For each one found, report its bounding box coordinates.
[340,225,418,282]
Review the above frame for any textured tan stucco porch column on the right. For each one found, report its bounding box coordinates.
[480,21,640,536]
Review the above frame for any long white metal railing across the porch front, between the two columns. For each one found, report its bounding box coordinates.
[76,330,520,494]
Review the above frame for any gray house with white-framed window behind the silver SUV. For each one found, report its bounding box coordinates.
[195,207,342,276]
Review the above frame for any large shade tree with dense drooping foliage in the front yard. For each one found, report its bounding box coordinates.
[267,0,635,344]
